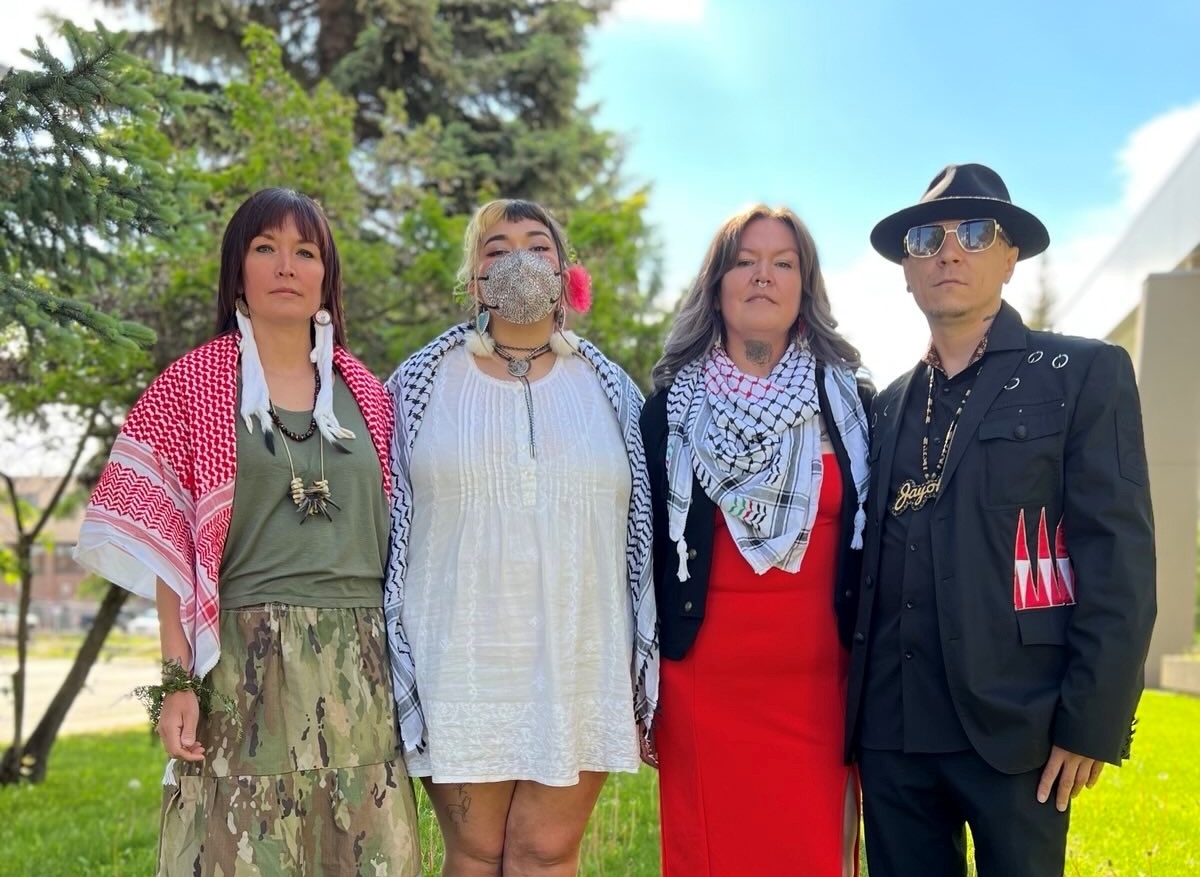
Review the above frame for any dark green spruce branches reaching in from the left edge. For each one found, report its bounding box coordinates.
[0,25,178,345]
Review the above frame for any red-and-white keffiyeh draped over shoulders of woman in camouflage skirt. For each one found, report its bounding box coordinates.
[76,332,395,675]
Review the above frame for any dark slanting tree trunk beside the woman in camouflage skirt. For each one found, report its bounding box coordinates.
[0,584,130,786]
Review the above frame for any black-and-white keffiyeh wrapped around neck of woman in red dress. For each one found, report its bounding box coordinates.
[667,344,868,582]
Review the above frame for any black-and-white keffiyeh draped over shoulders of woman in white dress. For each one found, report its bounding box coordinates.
[384,324,659,751]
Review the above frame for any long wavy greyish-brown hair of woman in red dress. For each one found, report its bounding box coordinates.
[650,204,863,390]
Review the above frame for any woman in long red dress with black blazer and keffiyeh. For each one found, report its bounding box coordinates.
[641,205,870,877]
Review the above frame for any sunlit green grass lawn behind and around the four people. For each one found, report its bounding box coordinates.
[0,692,1200,877]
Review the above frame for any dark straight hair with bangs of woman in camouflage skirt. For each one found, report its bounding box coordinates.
[217,188,346,347]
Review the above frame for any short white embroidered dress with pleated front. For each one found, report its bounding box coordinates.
[402,347,638,786]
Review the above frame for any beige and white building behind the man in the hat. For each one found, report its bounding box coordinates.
[1055,140,1200,693]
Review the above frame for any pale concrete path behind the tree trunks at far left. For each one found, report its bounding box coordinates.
[0,657,158,745]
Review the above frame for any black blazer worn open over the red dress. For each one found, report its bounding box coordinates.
[641,364,874,661]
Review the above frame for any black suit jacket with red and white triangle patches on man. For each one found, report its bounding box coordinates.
[846,305,1156,774]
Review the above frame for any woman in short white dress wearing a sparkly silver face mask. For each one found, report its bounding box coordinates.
[385,200,658,877]
